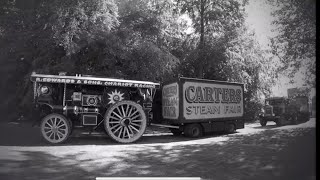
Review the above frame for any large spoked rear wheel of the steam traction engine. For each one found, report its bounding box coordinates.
[104,101,147,143]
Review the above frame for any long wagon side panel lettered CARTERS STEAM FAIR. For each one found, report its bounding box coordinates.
[181,79,244,123]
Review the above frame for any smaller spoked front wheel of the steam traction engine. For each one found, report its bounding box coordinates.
[40,113,71,144]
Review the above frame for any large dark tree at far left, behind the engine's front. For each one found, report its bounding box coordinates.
[0,0,117,121]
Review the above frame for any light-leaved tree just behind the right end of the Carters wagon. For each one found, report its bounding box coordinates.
[224,26,278,120]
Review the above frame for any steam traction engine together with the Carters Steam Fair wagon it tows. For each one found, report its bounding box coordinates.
[31,73,244,143]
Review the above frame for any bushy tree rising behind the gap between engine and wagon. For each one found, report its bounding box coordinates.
[115,0,183,81]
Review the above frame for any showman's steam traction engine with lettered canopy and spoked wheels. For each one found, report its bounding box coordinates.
[31,73,160,143]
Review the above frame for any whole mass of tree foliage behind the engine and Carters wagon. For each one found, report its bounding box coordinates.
[0,0,274,121]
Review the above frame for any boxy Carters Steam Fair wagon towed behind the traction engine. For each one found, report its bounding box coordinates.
[153,77,244,137]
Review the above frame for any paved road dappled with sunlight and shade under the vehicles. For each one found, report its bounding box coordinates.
[0,119,316,180]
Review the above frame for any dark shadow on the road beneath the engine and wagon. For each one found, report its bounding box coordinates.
[0,123,235,146]
